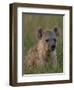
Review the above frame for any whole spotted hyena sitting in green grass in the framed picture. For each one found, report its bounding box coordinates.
[25,27,58,66]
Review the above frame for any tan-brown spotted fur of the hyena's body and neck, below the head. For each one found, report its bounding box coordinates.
[26,40,49,66]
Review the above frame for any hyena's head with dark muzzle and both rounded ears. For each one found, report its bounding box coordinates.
[38,27,59,51]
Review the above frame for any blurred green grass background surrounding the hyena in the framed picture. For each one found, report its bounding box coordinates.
[22,13,63,74]
